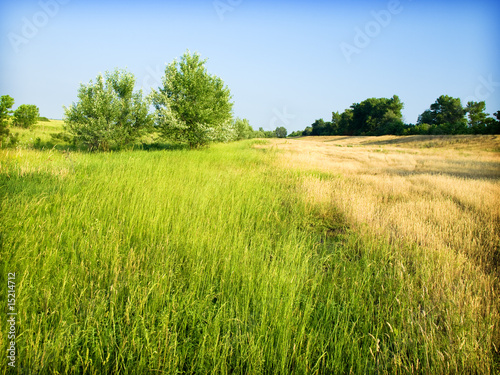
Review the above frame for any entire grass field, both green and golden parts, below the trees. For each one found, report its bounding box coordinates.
[0,126,500,374]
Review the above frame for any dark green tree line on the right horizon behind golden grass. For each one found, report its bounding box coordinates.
[290,95,500,137]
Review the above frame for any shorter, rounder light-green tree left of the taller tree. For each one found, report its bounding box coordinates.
[64,69,152,151]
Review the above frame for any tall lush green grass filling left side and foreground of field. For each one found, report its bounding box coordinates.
[0,141,498,374]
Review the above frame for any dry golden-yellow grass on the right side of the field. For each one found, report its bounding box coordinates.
[258,135,500,273]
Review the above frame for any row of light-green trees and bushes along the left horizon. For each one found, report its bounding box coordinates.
[0,51,287,151]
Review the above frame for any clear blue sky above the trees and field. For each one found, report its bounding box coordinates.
[0,0,500,132]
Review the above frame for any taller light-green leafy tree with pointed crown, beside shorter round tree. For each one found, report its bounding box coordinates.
[151,51,233,148]
